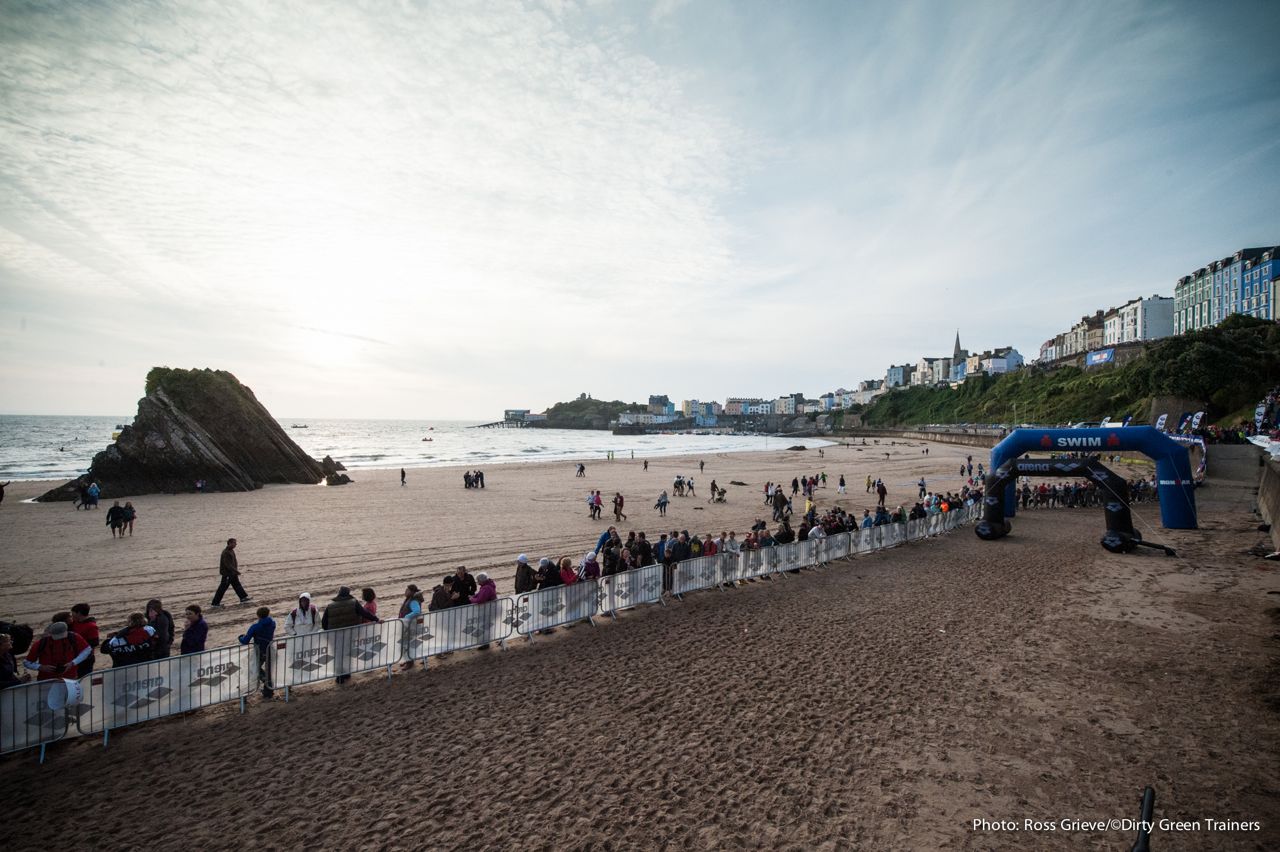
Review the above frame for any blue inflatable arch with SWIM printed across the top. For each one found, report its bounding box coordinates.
[991,426,1196,530]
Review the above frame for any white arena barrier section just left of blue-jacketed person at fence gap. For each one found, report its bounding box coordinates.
[70,643,257,734]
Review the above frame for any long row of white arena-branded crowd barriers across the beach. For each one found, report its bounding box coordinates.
[0,505,982,761]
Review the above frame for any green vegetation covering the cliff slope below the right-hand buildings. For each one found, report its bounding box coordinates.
[863,316,1280,426]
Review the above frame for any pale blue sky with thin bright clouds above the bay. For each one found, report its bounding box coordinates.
[0,0,1280,420]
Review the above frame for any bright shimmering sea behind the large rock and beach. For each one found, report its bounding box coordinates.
[0,414,831,480]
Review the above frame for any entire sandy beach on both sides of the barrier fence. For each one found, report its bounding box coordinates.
[0,445,1280,851]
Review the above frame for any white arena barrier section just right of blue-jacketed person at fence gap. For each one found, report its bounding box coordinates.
[273,619,404,701]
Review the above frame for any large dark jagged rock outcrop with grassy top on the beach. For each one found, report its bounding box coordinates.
[40,367,343,500]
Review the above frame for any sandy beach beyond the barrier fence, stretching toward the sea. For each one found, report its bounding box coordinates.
[0,441,987,647]
